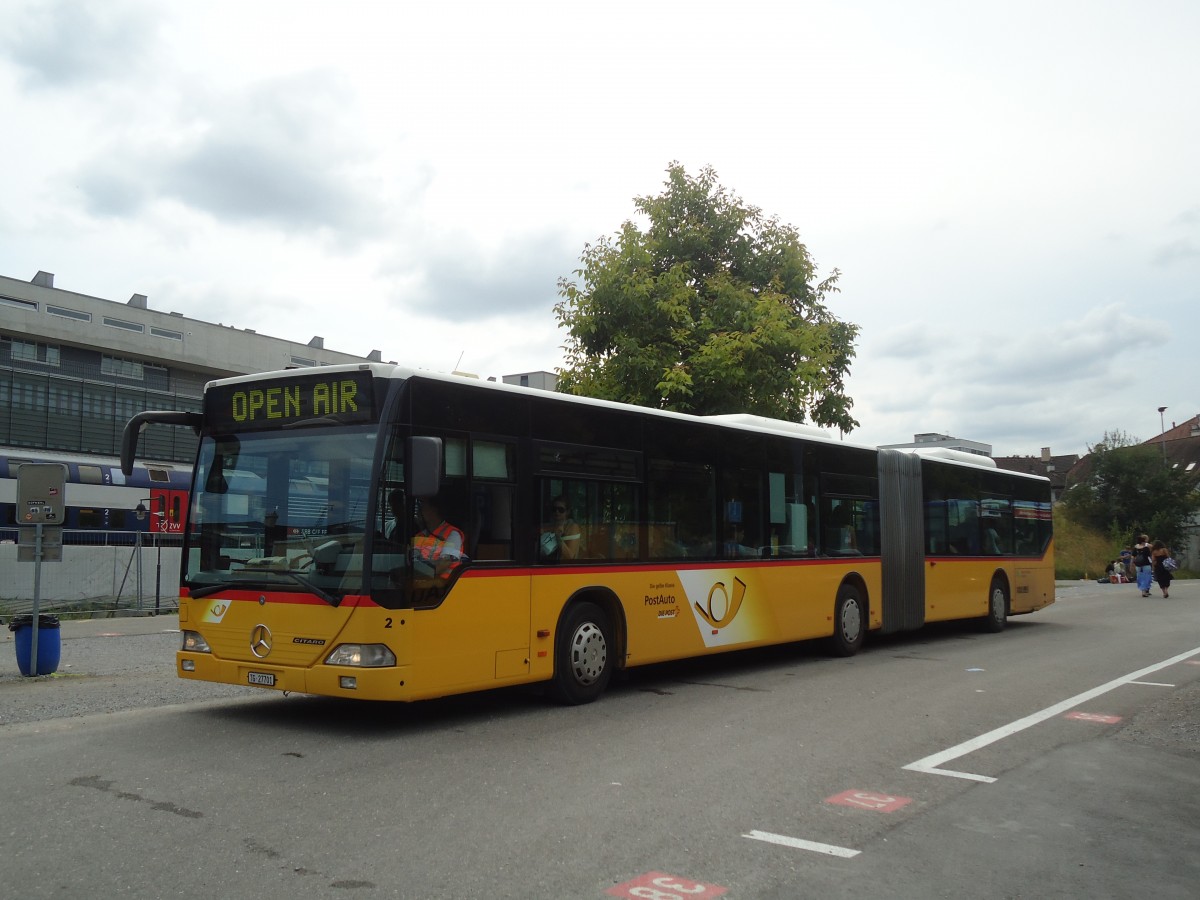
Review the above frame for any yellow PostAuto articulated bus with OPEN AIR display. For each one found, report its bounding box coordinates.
[121,364,1054,703]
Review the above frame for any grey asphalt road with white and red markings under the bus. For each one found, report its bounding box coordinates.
[0,582,1200,900]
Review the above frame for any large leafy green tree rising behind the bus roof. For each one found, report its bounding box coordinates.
[554,162,858,432]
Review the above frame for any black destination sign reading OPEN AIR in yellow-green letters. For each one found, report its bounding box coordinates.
[204,372,374,431]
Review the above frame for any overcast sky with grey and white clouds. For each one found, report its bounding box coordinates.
[0,0,1200,455]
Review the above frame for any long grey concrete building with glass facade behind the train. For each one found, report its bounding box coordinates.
[0,271,393,462]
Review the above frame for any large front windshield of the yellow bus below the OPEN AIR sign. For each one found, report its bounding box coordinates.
[184,425,377,605]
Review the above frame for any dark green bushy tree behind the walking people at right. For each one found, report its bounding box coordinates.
[1062,432,1200,547]
